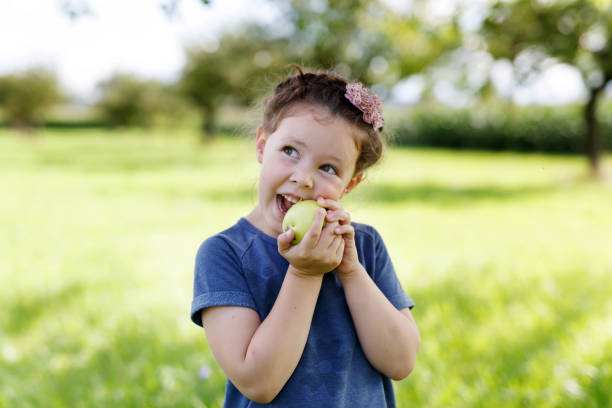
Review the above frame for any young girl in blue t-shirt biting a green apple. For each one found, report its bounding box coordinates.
[191,67,420,408]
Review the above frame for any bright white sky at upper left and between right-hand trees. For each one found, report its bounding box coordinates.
[0,0,604,104]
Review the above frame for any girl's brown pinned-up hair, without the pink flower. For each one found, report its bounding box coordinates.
[263,65,384,174]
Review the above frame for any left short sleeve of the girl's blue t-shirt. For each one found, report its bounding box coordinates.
[191,236,255,326]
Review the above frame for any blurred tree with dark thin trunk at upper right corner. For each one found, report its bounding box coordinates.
[481,0,612,177]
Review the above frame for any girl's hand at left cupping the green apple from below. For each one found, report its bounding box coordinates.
[277,209,344,277]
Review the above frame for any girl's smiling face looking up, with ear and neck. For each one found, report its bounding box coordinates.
[247,107,363,237]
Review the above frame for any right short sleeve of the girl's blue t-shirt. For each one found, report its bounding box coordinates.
[372,228,415,309]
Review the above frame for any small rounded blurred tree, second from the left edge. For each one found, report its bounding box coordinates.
[96,74,179,126]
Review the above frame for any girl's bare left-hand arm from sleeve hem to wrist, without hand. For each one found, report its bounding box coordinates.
[202,267,322,404]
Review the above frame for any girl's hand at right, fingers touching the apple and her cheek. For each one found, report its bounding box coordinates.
[317,198,361,279]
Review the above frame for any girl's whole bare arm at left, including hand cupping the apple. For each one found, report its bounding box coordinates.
[202,212,344,403]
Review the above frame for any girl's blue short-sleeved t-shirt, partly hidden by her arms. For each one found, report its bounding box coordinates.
[191,218,414,408]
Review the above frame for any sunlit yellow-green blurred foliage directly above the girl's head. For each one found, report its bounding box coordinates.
[270,0,462,97]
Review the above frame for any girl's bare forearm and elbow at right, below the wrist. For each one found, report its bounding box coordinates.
[338,265,420,380]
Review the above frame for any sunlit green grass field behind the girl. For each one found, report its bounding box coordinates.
[0,130,612,408]
